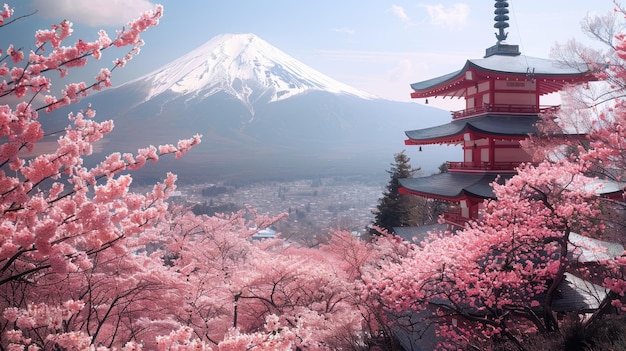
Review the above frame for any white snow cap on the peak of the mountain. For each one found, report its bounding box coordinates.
[135,34,376,112]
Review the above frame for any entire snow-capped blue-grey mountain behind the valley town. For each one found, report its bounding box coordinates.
[45,34,454,182]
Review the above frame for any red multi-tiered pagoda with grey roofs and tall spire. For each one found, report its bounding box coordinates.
[400,0,593,226]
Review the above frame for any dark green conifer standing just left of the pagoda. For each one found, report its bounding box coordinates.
[369,151,420,235]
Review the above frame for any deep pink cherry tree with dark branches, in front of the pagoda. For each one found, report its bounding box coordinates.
[360,161,600,349]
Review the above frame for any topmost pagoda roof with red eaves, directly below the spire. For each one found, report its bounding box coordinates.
[411,55,594,98]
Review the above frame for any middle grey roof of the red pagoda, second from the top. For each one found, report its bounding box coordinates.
[404,114,539,145]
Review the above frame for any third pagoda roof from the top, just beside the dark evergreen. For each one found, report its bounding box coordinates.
[399,173,512,200]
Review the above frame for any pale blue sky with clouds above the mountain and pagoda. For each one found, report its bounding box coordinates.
[0,0,613,107]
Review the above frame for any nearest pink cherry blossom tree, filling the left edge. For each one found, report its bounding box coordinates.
[0,5,205,350]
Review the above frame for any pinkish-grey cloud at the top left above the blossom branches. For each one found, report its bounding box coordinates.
[34,0,154,27]
